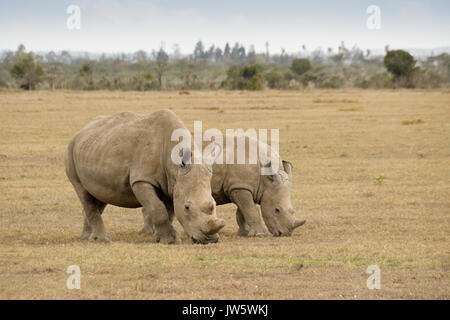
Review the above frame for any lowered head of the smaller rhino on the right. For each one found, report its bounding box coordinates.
[260,160,306,237]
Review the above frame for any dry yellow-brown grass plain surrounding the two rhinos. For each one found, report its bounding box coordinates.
[0,90,450,299]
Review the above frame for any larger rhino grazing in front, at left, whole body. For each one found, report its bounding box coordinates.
[65,110,225,243]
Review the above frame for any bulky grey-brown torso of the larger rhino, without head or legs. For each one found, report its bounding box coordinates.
[68,110,183,207]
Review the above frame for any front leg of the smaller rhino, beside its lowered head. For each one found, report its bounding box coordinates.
[231,190,267,237]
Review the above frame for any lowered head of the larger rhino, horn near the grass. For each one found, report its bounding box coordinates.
[173,150,225,244]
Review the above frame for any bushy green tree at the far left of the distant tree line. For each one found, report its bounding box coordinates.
[10,52,44,90]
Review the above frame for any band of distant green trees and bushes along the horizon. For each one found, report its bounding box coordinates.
[0,41,450,91]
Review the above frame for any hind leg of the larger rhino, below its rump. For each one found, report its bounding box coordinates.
[75,187,109,241]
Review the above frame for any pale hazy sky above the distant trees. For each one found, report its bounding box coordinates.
[0,0,450,53]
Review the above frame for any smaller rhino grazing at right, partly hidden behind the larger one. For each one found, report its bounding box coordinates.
[141,136,306,237]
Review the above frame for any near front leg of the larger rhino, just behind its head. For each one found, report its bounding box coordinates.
[132,182,179,244]
